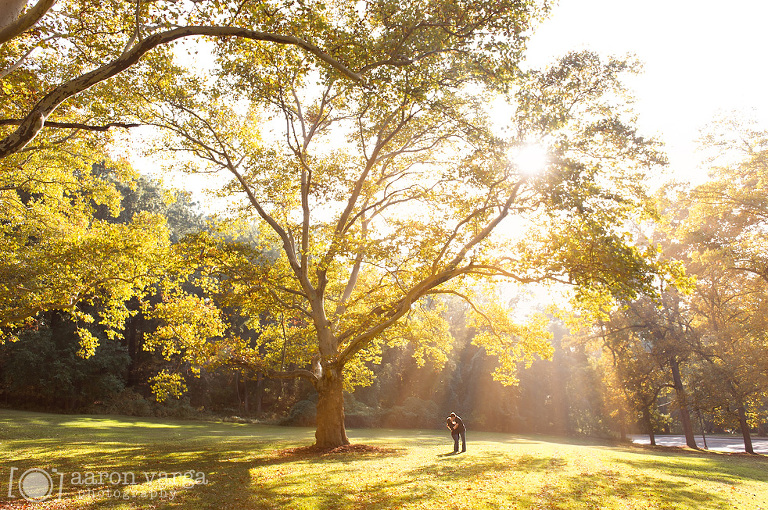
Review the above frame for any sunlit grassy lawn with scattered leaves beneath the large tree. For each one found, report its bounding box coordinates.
[0,410,768,510]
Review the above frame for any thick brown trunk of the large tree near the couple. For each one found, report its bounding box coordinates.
[315,368,349,448]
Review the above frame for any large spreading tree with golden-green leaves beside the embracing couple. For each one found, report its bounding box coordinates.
[142,48,663,446]
